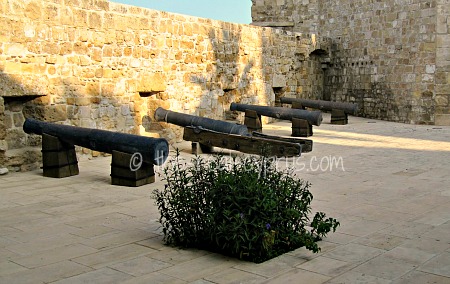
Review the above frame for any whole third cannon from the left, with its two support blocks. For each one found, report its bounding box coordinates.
[230,103,322,137]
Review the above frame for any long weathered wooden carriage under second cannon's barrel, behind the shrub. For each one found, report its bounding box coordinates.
[183,126,313,157]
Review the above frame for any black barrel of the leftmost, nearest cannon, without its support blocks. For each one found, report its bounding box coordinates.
[23,118,169,166]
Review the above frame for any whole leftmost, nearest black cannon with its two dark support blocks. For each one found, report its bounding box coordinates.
[23,118,169,186]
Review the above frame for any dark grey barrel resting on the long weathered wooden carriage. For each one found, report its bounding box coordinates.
[155,107,249,136]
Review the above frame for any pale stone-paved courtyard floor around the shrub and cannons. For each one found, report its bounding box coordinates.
[0,114,450,284]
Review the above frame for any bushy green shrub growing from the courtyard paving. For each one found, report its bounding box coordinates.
[155,153,339,262]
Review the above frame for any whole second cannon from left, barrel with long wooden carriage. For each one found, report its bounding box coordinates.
[155,107,312,157]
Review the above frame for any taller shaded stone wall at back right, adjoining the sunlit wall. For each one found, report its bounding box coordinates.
[252,0,450,125]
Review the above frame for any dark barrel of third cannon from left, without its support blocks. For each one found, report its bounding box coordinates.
[230,103,322,126]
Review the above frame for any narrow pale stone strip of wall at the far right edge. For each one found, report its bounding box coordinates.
[435,0,450,125]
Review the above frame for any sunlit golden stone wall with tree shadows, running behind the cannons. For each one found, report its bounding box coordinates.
[0,0,326,170]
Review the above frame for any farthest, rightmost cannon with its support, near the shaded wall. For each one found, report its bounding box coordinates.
[280,97,359,124]
